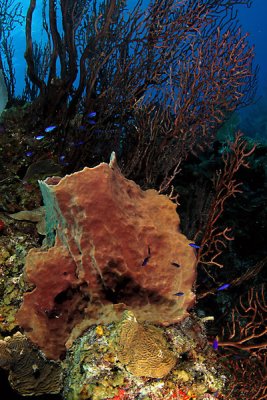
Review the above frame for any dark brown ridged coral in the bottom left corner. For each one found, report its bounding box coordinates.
[0,332,62,396]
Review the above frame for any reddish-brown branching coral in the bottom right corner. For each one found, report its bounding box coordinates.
[219,285,267,400]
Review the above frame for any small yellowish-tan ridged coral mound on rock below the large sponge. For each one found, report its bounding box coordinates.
[116,311,176,378]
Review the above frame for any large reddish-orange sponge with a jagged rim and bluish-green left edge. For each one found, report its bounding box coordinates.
[17,154,196,359]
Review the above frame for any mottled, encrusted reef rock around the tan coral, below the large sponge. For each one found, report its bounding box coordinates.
[63,311,227,400]
